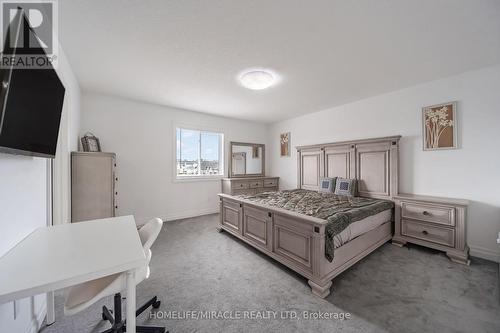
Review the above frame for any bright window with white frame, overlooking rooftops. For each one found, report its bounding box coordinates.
[176,127,224,179]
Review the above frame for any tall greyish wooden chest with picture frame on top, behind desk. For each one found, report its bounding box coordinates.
[71,152,118,222]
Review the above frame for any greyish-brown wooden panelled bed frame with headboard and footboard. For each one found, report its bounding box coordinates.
[219,136,401,298]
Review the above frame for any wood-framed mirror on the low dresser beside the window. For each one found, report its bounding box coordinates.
[229,142,266,177]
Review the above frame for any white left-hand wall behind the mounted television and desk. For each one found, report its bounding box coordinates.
[0,49,80,332]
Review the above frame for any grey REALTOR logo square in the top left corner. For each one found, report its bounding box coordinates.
[0,0,58,69]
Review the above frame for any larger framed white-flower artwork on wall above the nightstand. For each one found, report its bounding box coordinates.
[422,102,457,150]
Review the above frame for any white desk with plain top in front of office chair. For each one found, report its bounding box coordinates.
[0,216,146,333]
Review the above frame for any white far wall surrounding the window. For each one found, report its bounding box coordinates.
[80,93,267,223]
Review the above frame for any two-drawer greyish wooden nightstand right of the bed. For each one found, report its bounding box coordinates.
[392,194,470,265]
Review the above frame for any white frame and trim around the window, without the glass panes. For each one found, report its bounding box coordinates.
[172,123,225,182]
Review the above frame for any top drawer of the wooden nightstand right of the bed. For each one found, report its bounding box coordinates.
[401,202,455,226]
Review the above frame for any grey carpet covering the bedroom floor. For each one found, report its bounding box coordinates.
[42,215,500,333]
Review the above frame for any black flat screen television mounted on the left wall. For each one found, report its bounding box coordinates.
[0,11,65,158]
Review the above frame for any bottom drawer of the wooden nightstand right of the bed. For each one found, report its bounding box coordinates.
[401,219,455,247]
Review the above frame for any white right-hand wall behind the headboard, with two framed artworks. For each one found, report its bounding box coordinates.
[269,66,500,260]
